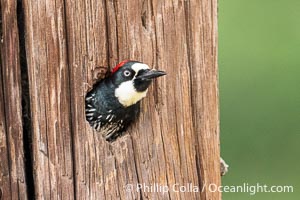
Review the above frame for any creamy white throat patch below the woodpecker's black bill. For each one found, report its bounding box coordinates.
[115,80,148,107]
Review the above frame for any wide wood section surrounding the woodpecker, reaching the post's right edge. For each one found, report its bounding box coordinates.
[66,0,220,199]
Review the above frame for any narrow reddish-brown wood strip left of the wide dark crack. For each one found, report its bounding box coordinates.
[0,0,27,199]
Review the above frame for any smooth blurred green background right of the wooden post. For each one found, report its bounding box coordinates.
[219,0,300,200]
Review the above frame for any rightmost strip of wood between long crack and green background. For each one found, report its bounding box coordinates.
[187,0,221,199]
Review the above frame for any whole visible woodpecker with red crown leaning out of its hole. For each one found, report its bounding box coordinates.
[85,60,166,141]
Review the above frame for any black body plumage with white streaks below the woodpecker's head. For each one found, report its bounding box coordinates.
[85,78,140,141]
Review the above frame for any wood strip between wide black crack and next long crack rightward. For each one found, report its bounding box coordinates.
[23,0,75,199]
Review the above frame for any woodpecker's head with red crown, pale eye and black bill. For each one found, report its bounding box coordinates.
[111,60,166,107]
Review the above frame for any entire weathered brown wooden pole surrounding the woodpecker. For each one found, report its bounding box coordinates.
[0,0,221,200]
